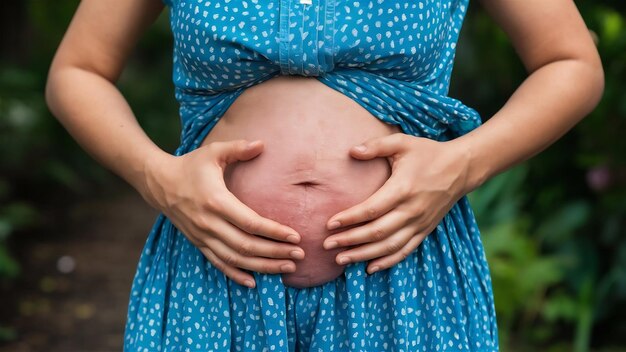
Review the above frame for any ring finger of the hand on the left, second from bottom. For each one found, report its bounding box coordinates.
[202,238,296,274]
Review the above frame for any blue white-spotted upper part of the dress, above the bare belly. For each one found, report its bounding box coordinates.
[158,0,481,151]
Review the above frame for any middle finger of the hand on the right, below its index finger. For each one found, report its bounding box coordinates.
[323,211,409,249]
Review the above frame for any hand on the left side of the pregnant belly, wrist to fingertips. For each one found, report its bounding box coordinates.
[140,140,304,287]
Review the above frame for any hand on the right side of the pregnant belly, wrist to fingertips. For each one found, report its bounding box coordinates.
[324,133,470,274]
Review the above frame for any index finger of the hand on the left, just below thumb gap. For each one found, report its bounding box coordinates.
[219,192,300,243]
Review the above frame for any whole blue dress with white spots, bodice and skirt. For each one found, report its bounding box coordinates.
[124,0,498,351]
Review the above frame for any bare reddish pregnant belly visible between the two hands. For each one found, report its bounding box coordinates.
[202,76,400,287]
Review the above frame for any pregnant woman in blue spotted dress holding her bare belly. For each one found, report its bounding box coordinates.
[46,0,604,351]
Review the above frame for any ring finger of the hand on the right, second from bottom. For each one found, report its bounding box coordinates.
[336,226,417,265]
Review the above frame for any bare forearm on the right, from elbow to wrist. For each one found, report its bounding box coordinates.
[451,59,604,192]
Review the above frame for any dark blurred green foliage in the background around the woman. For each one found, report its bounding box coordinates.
[0,0,626,351]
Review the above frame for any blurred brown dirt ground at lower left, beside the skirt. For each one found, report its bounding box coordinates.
[0,189,158,352]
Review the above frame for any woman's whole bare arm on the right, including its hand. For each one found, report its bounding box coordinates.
[325,0,604,273]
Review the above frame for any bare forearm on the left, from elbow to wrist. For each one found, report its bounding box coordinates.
[46,65,170,195]
